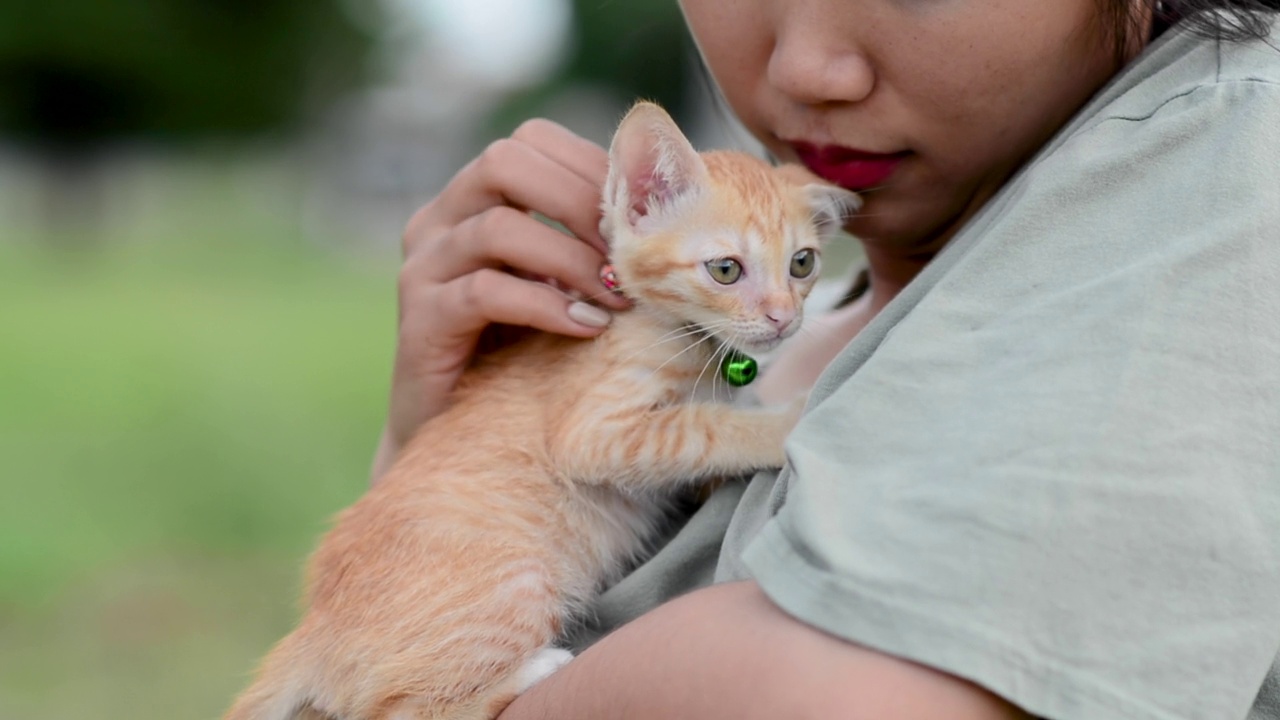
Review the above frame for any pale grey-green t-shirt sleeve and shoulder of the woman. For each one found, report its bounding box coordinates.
[742,81,1280,720]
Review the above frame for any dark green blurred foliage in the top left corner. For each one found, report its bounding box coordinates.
[0,0,374,151]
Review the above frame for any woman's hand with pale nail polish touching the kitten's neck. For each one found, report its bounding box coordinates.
[372,120,626,480]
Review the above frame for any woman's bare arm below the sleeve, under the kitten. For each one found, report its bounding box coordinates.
[500,583,1021,720]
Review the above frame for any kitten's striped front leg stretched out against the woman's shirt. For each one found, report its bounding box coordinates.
[553,400,804,487]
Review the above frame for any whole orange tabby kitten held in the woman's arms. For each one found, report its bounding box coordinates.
[227,102,858,720]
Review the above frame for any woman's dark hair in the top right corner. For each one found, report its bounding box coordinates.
[1097,0,1280,59]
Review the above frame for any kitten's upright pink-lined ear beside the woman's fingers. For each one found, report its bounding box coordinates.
[604,102,707,227]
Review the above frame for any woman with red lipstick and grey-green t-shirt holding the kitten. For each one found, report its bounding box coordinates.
[374,0,1280,720]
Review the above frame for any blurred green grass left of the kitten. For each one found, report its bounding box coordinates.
[0,183,396,720]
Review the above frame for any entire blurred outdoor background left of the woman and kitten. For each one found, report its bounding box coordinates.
[0,0,732,720]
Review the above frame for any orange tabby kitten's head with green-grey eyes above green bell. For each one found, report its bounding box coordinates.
[600,102,860,351]
